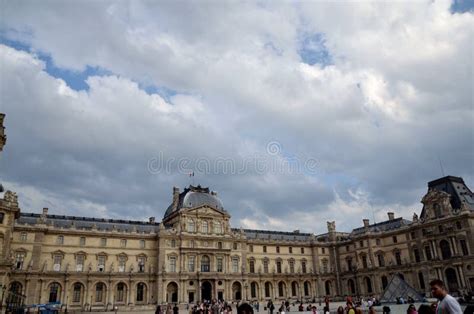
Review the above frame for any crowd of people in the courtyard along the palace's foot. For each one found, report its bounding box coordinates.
[155,280,466,314]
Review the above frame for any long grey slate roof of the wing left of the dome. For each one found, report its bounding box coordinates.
[16,213,159,233]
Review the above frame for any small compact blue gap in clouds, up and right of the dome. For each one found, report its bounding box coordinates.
[298,33,332,67]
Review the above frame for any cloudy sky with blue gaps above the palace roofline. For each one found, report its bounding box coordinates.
[0,0,474,233]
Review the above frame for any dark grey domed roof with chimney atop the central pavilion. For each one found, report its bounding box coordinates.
[165,185,225,218]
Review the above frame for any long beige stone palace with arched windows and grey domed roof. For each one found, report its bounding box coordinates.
[0,177,474,310]
